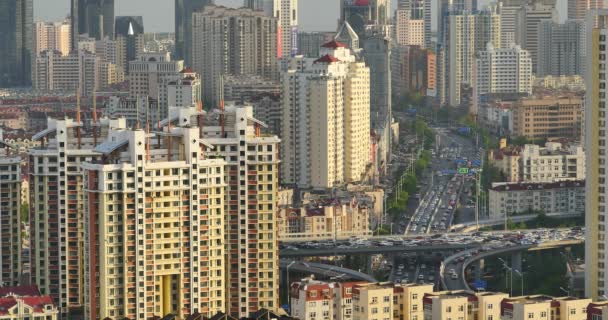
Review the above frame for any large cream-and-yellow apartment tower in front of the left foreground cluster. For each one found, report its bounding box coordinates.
[82,114,228,319]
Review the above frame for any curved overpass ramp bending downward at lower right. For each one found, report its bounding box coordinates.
[439,239,584,290]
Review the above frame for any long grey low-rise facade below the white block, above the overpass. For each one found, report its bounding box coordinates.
[489,180,585,219]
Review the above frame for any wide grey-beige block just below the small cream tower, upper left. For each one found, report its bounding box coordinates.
[32,50,100,96]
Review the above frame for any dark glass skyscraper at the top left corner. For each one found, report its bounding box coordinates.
[0,0,34,87]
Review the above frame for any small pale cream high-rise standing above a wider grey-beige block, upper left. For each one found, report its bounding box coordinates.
[34,20,72,56]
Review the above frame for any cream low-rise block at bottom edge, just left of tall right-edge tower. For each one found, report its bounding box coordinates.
[500,295,591,320]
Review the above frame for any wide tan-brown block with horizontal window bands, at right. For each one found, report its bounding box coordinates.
[511,96,584,140]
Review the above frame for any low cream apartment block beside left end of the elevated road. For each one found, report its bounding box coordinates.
[278,199,372,240]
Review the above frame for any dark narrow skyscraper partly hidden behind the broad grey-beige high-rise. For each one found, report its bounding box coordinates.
[173,0,213,67]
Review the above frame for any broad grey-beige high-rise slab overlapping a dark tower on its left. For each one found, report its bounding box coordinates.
[192,6,279,106]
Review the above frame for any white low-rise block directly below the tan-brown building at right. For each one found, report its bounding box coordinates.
[490,142,585,182]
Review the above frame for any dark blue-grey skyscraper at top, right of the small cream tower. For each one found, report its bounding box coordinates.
[70,0,114,49]
